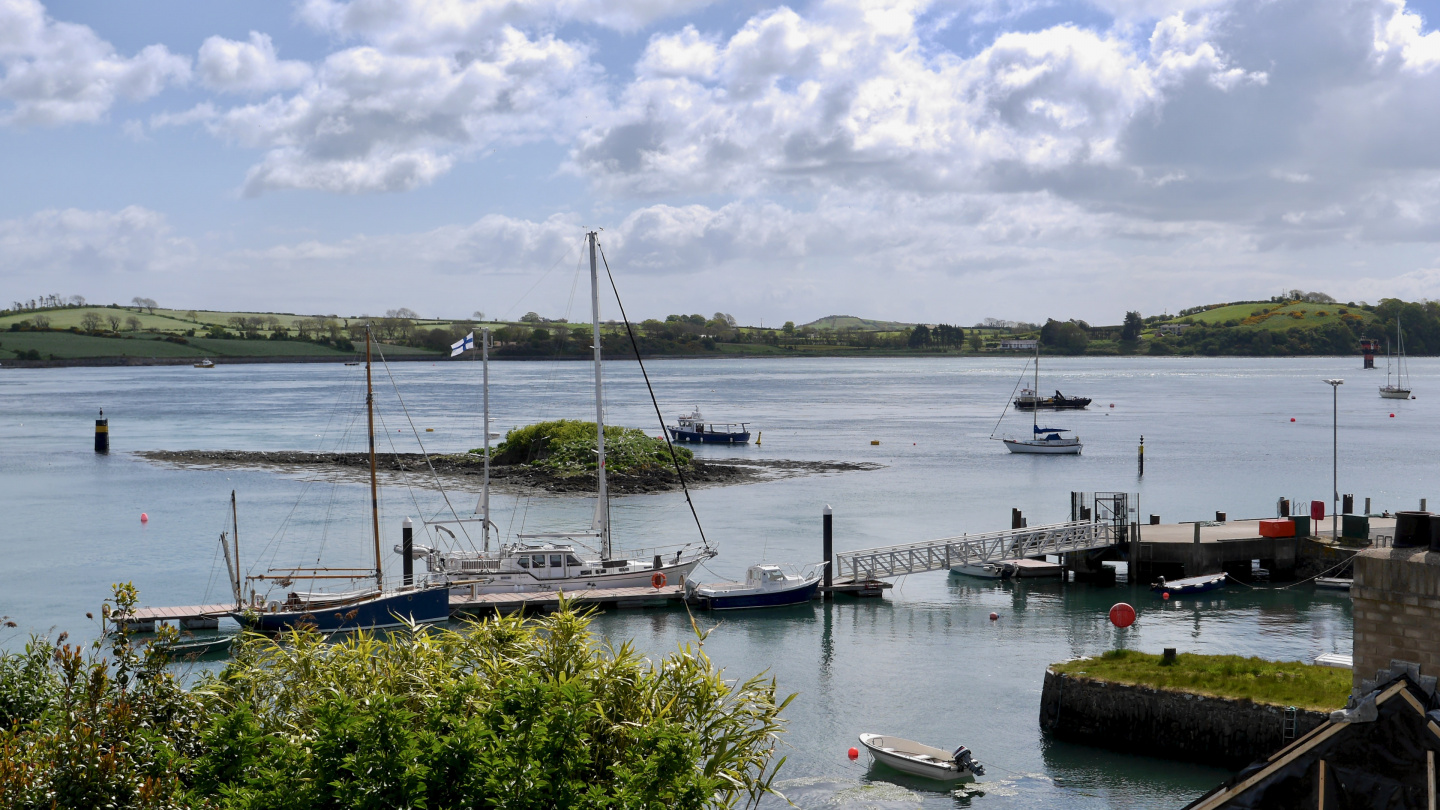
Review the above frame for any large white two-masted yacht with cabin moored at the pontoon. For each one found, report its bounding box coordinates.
[412,231,716,595]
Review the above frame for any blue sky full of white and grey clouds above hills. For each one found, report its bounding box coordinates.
[0,0,1440,326]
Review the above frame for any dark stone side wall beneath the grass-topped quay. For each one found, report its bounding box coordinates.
[1040,670,1329,770]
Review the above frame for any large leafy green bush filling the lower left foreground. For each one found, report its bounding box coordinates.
[0,585,793,810]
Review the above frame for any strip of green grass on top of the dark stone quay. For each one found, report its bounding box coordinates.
[1050,650,1351,712]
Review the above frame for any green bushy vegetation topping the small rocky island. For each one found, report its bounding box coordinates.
[471,419,694,477]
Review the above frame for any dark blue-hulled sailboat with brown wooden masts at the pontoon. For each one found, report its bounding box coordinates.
[222,326,449,633]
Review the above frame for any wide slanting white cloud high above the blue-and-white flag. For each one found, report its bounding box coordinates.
[194,27,600,196]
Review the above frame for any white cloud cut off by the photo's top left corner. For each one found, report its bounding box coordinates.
[0,0,190,125]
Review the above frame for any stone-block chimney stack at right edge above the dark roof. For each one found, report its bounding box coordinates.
[1351,548,1440,689]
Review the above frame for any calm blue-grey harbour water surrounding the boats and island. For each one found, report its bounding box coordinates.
[0,357,1416,807]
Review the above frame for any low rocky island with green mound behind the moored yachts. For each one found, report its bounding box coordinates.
[137,419,883,494]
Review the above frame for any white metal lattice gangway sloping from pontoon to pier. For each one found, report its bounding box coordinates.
[835,520,1125,584]
